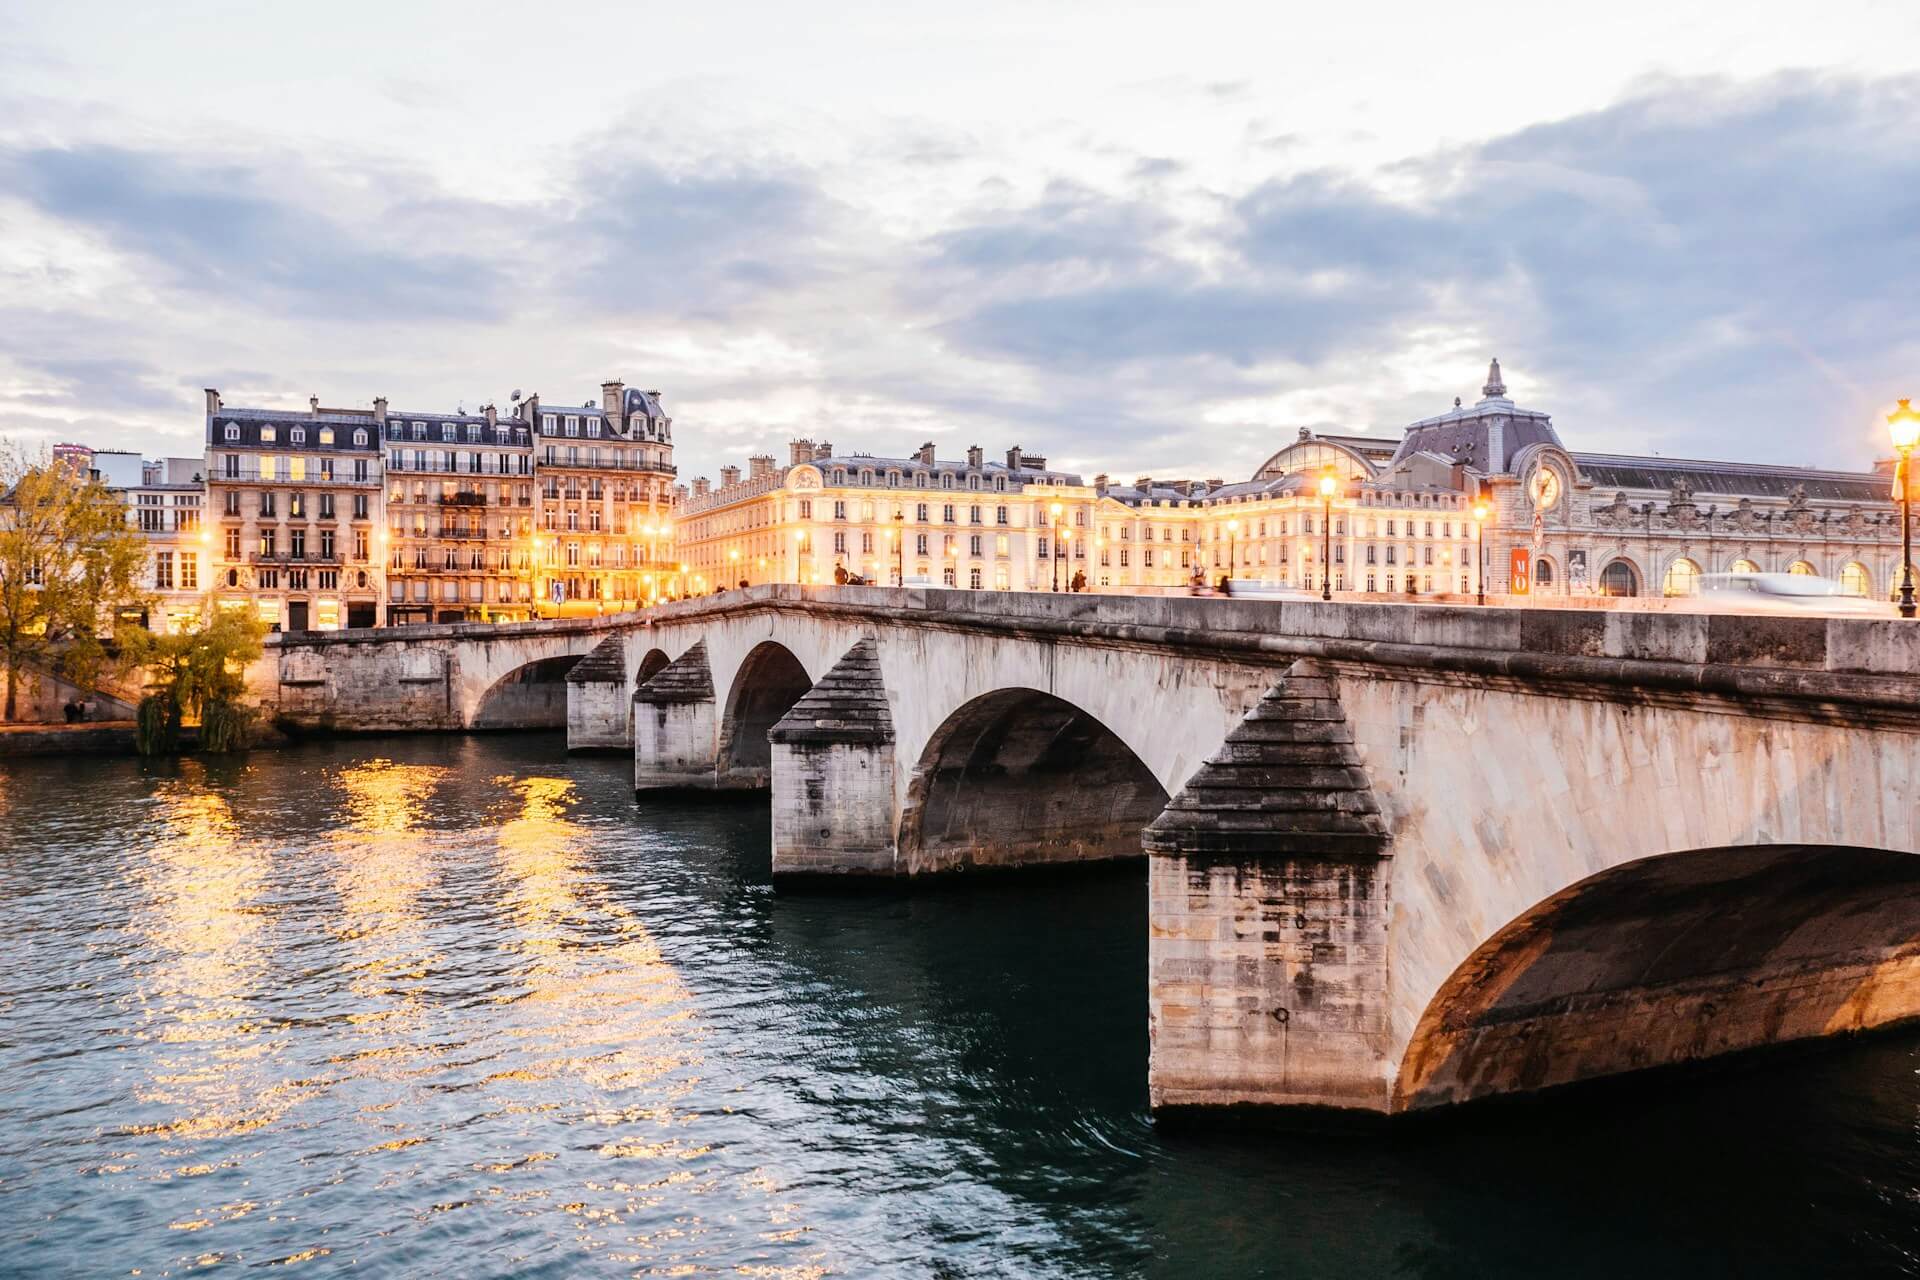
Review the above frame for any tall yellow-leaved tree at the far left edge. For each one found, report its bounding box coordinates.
[0,443,146,720]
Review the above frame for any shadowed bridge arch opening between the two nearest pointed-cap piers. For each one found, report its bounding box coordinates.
[899,687,1167,871]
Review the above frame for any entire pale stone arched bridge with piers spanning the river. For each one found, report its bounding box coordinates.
[263,585,1920,1113]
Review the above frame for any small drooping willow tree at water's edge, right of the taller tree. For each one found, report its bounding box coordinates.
[125,608,267,756]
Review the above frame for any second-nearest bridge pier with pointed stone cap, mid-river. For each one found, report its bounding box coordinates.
[768,639,897,879]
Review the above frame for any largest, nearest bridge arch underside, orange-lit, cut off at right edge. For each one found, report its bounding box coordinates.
[1392,844,1920,1111]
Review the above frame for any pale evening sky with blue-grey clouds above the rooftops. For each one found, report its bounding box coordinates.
[0,0,1920,485]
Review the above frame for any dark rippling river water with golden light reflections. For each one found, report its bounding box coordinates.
[0,735,1920,1278]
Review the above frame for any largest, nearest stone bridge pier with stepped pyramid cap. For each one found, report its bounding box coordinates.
[1144,662,1392,1111]
